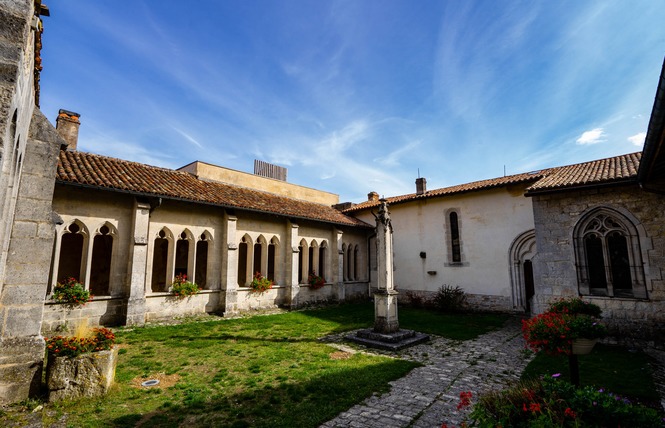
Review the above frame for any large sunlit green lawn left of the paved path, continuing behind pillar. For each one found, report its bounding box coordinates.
[24,303,506,427]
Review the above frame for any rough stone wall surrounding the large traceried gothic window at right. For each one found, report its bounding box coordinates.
[533,185,665,341]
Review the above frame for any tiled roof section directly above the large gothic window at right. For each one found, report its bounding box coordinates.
[527,152,641,195]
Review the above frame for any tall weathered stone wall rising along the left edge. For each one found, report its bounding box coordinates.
[0,0,62,403]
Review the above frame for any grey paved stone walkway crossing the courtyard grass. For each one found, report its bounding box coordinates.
[321,318,532,428]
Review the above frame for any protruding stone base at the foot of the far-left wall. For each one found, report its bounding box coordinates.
[0,336,44,404]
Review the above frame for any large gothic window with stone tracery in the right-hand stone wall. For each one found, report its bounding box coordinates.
[574,208,646,298]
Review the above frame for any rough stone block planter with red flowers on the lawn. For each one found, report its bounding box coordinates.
[44,328,118,401]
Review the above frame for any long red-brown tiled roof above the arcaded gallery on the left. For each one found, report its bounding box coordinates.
[56,150,369,227]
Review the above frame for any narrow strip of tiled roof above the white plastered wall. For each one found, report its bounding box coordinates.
[344,170,548,213]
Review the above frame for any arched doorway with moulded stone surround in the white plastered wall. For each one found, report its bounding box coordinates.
[509,229,536,312]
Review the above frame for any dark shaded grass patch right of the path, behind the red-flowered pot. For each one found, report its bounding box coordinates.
[522,344,660,403]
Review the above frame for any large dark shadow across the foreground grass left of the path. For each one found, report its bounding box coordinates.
[106,360,417,428]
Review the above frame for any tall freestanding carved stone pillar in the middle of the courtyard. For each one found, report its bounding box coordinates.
[374,199,399,333]
